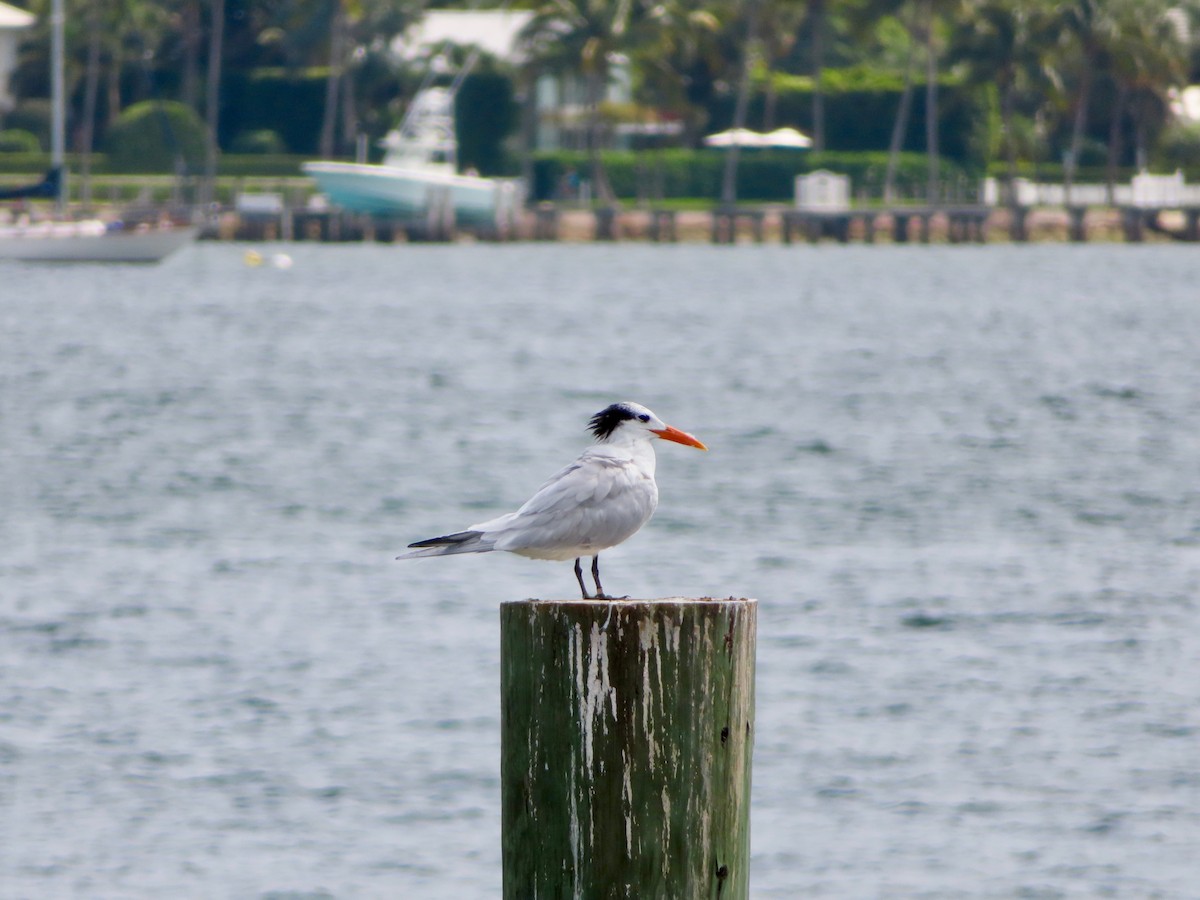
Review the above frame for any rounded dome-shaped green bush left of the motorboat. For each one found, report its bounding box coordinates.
[104,100,206,173]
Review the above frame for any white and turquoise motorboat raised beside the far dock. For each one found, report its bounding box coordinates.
[302,88,522,228]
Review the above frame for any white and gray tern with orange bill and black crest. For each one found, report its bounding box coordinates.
[396,402,708,600]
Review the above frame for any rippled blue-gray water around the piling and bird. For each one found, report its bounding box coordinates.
[0,245,1200,900]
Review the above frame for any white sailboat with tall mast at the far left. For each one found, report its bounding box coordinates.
[0,0,197,263]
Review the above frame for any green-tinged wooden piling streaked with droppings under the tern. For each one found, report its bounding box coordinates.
[500,598,757,900]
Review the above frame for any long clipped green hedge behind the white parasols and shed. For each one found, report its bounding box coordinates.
[530,150,972,202]
